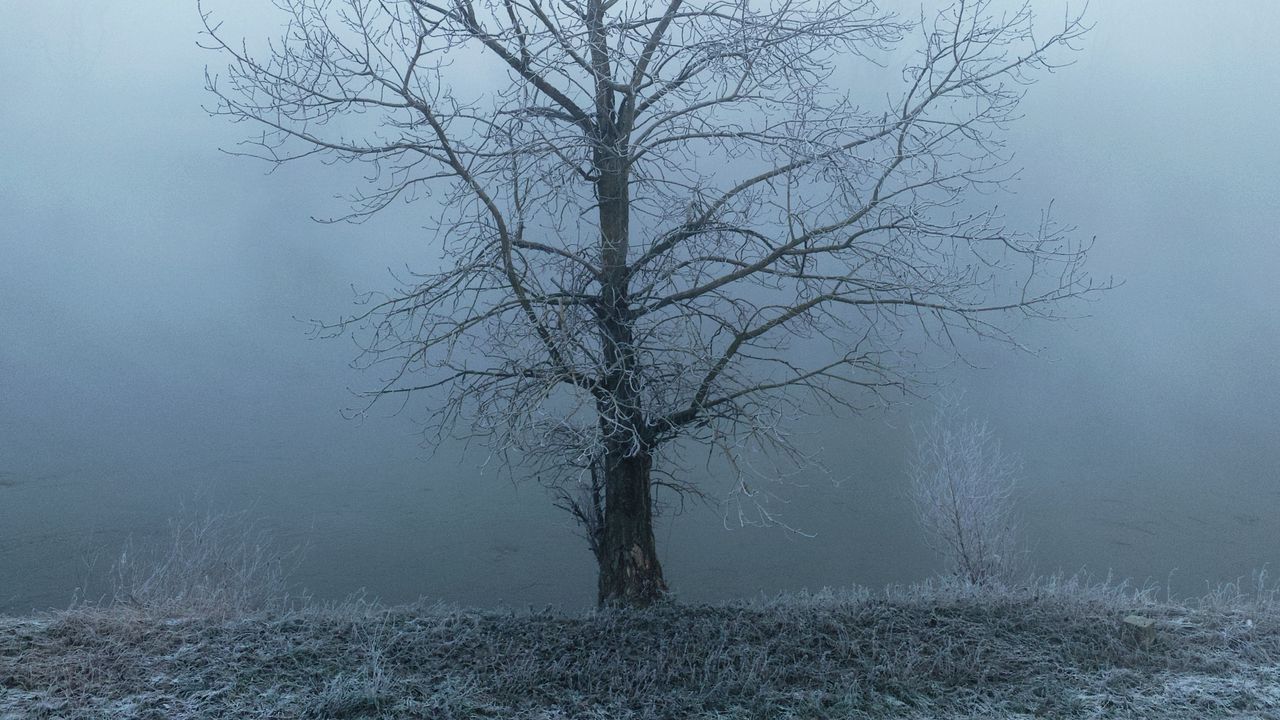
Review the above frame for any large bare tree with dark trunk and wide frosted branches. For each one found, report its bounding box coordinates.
[201,0,1097,603]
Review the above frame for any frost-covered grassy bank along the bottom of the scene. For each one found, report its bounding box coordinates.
[0,571,1280,720]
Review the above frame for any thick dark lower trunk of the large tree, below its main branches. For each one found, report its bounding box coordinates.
[598,452,667,606]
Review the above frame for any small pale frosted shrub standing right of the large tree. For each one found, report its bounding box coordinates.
[909,406,1020,584]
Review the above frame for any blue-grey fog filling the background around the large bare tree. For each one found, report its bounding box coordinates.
[0,0,1280,611]
